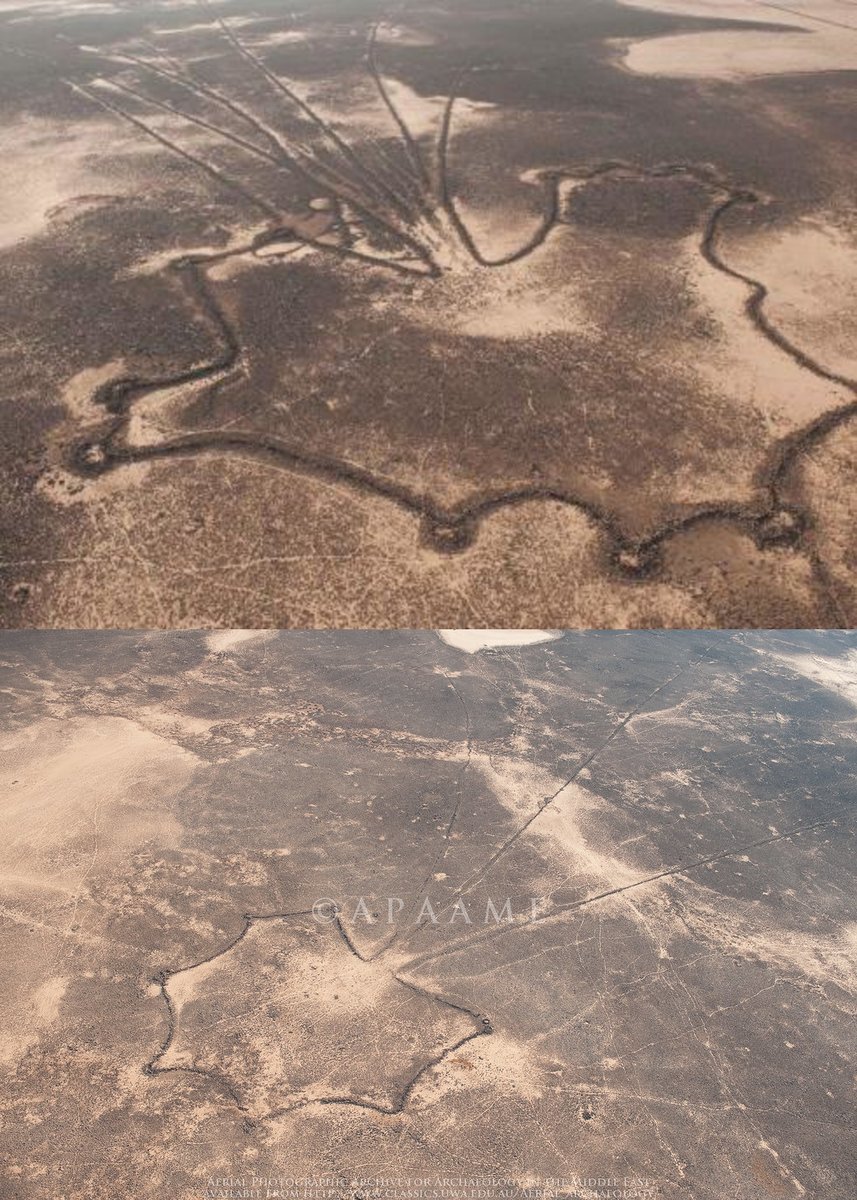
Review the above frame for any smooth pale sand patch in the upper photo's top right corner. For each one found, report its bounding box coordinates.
[613,0,857,79]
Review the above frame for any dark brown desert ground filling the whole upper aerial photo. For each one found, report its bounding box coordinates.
[0,0,857,628]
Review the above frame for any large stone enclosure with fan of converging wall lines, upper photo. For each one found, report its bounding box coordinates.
[56,20,855,559]
